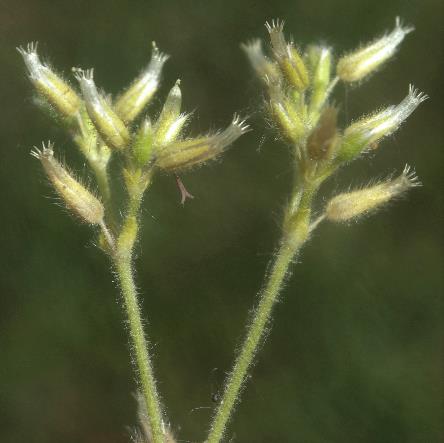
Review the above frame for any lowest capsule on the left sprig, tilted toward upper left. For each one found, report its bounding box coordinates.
[31,143,104,225]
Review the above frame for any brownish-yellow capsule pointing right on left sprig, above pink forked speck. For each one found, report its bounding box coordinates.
[156,116,249,172]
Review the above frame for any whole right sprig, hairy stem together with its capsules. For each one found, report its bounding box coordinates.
[206,19,426,443]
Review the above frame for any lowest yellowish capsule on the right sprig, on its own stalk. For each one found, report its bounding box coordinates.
[325,166,421,222]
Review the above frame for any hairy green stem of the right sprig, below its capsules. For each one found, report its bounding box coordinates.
[207,190,313,443]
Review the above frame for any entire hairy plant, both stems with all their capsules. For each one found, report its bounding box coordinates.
[19,19,427,443]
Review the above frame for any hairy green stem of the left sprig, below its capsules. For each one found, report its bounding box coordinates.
[113,176,165,443]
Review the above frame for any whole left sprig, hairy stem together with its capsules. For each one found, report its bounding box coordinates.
[18,38,249,443]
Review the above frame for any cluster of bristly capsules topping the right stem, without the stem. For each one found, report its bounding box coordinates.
[242,18,427,227]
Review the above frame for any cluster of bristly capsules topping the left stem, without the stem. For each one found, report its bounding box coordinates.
[18,43,248,239]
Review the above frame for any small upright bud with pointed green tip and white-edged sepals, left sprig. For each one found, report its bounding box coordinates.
[154,80,190,146]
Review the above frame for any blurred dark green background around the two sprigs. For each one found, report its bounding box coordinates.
[0,0,444,443]
